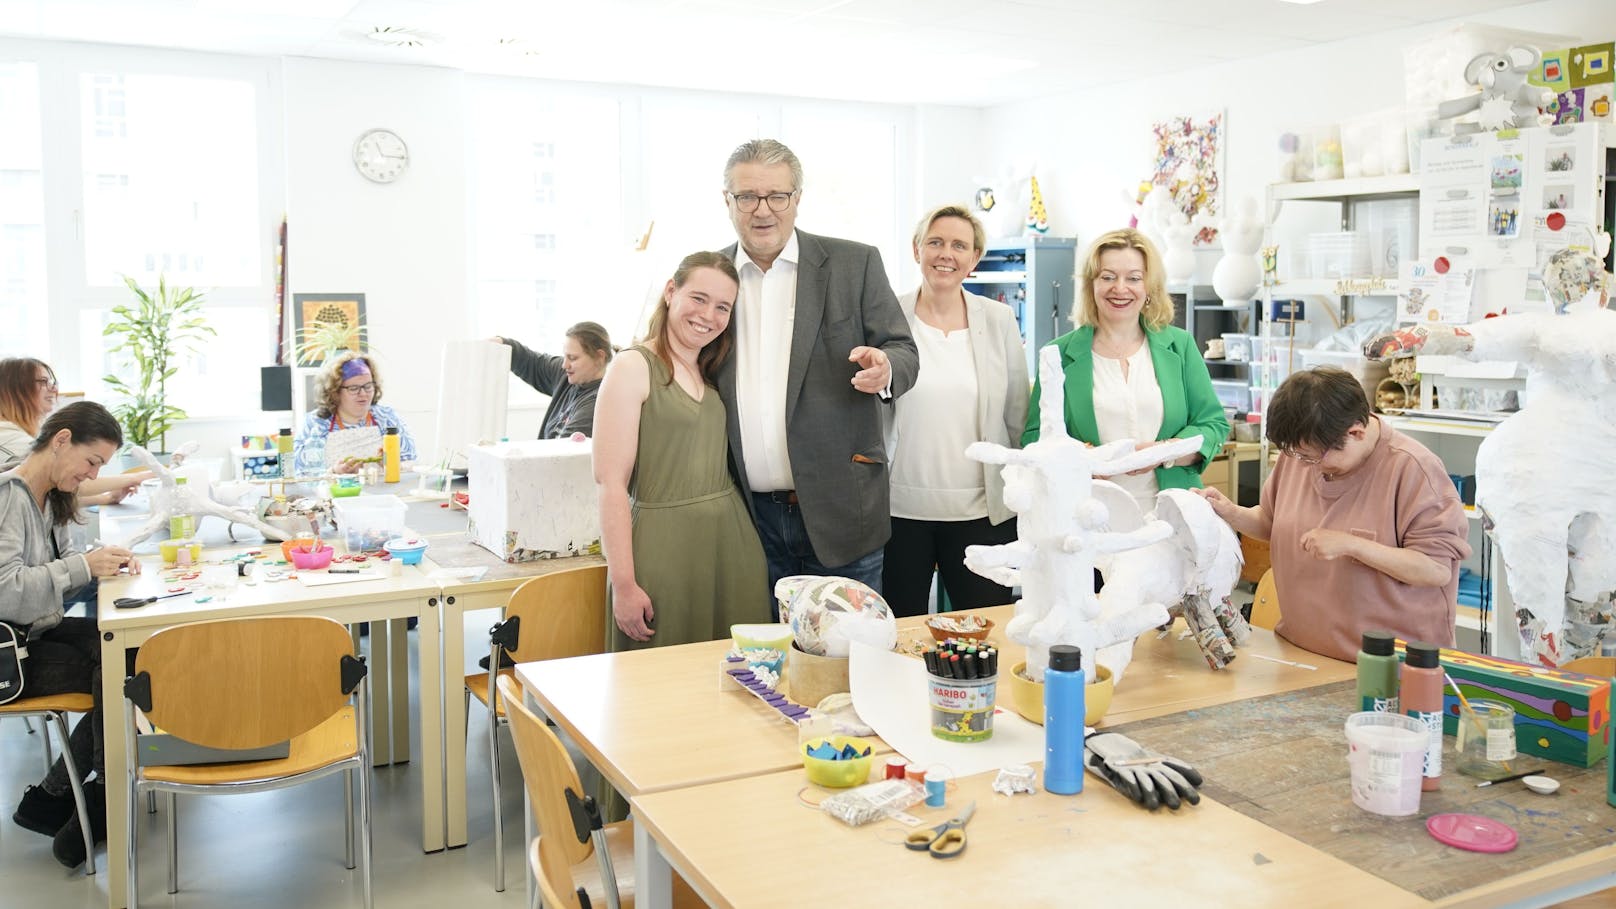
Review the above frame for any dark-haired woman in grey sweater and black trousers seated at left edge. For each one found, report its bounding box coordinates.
[0,401,141,869]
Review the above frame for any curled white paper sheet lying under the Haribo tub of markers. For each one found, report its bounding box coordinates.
[848,642,1044,776]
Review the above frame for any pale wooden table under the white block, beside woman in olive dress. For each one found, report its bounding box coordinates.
[422,532,606,849]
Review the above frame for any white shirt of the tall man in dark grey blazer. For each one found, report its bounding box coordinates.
[735,231,798,492]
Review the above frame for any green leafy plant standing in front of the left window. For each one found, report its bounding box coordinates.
[102,275,218,448]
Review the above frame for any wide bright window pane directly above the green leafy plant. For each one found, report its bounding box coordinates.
[79,73,265,286]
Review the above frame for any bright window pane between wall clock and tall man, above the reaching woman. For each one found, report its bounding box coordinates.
[469,81,620,378]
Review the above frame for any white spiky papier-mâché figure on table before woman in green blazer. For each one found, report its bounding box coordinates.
[965,345,1201,681]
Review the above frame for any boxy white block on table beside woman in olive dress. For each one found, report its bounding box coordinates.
[467,438,601,561]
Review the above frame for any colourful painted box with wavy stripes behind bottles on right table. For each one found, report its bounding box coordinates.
[1398,641,1611,767]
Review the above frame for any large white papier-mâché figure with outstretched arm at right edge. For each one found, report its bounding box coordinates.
[1364,238,1616,666]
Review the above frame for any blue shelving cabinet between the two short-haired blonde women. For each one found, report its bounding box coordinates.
[965,236,1078,374]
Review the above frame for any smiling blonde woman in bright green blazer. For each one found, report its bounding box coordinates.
[1021,230,1228,511]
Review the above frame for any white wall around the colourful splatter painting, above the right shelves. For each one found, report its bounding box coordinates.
[979,0,1616,281]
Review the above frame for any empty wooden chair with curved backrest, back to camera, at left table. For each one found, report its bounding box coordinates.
[123,616,372,909]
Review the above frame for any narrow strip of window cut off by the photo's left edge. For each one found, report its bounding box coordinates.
[0,63,50,357]
